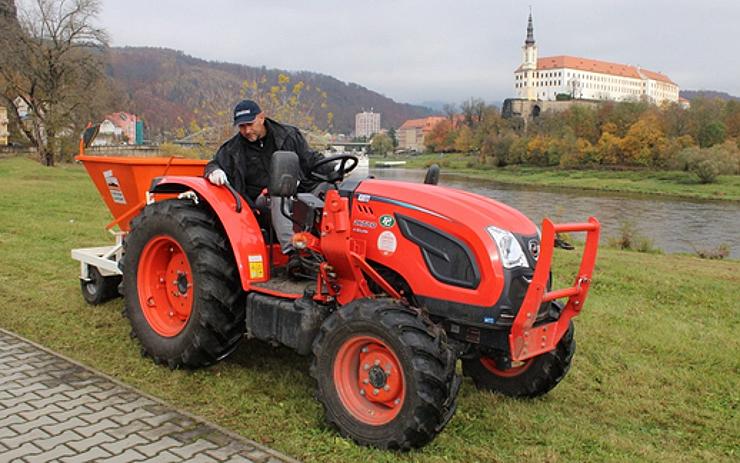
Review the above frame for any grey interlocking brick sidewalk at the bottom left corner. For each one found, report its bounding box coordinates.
[0,329,296,463]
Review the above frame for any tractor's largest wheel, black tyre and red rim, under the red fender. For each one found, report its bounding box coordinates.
[124,200,245,368]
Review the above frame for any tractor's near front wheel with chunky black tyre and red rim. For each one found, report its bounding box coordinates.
[311,299,460,450]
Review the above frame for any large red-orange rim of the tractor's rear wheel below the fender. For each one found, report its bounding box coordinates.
[136,236,194,337]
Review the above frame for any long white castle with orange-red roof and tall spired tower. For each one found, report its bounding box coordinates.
[514,13,679,104]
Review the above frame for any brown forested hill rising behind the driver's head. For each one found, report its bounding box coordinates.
[109,47,431,136]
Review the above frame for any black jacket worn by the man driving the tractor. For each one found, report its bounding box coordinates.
[204,118,322,200]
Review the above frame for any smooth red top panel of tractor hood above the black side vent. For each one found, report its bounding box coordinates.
[355,179,537,236]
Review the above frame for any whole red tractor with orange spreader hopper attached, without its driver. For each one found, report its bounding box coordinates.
[72,128,600,450]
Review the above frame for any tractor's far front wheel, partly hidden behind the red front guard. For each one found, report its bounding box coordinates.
[462,323,576,398]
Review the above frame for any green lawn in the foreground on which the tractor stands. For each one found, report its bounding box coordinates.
[0,158,740,462]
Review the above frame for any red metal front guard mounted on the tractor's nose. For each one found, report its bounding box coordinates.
[509,217,601,362]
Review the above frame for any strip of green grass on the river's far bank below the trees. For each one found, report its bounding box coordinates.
[376,153,740,201]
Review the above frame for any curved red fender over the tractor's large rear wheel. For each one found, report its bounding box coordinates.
[149,176,270,291]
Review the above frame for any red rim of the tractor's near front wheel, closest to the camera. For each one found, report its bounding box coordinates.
[333,336,406,426]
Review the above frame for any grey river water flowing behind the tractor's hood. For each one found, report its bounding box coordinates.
[370,169,740,259]
